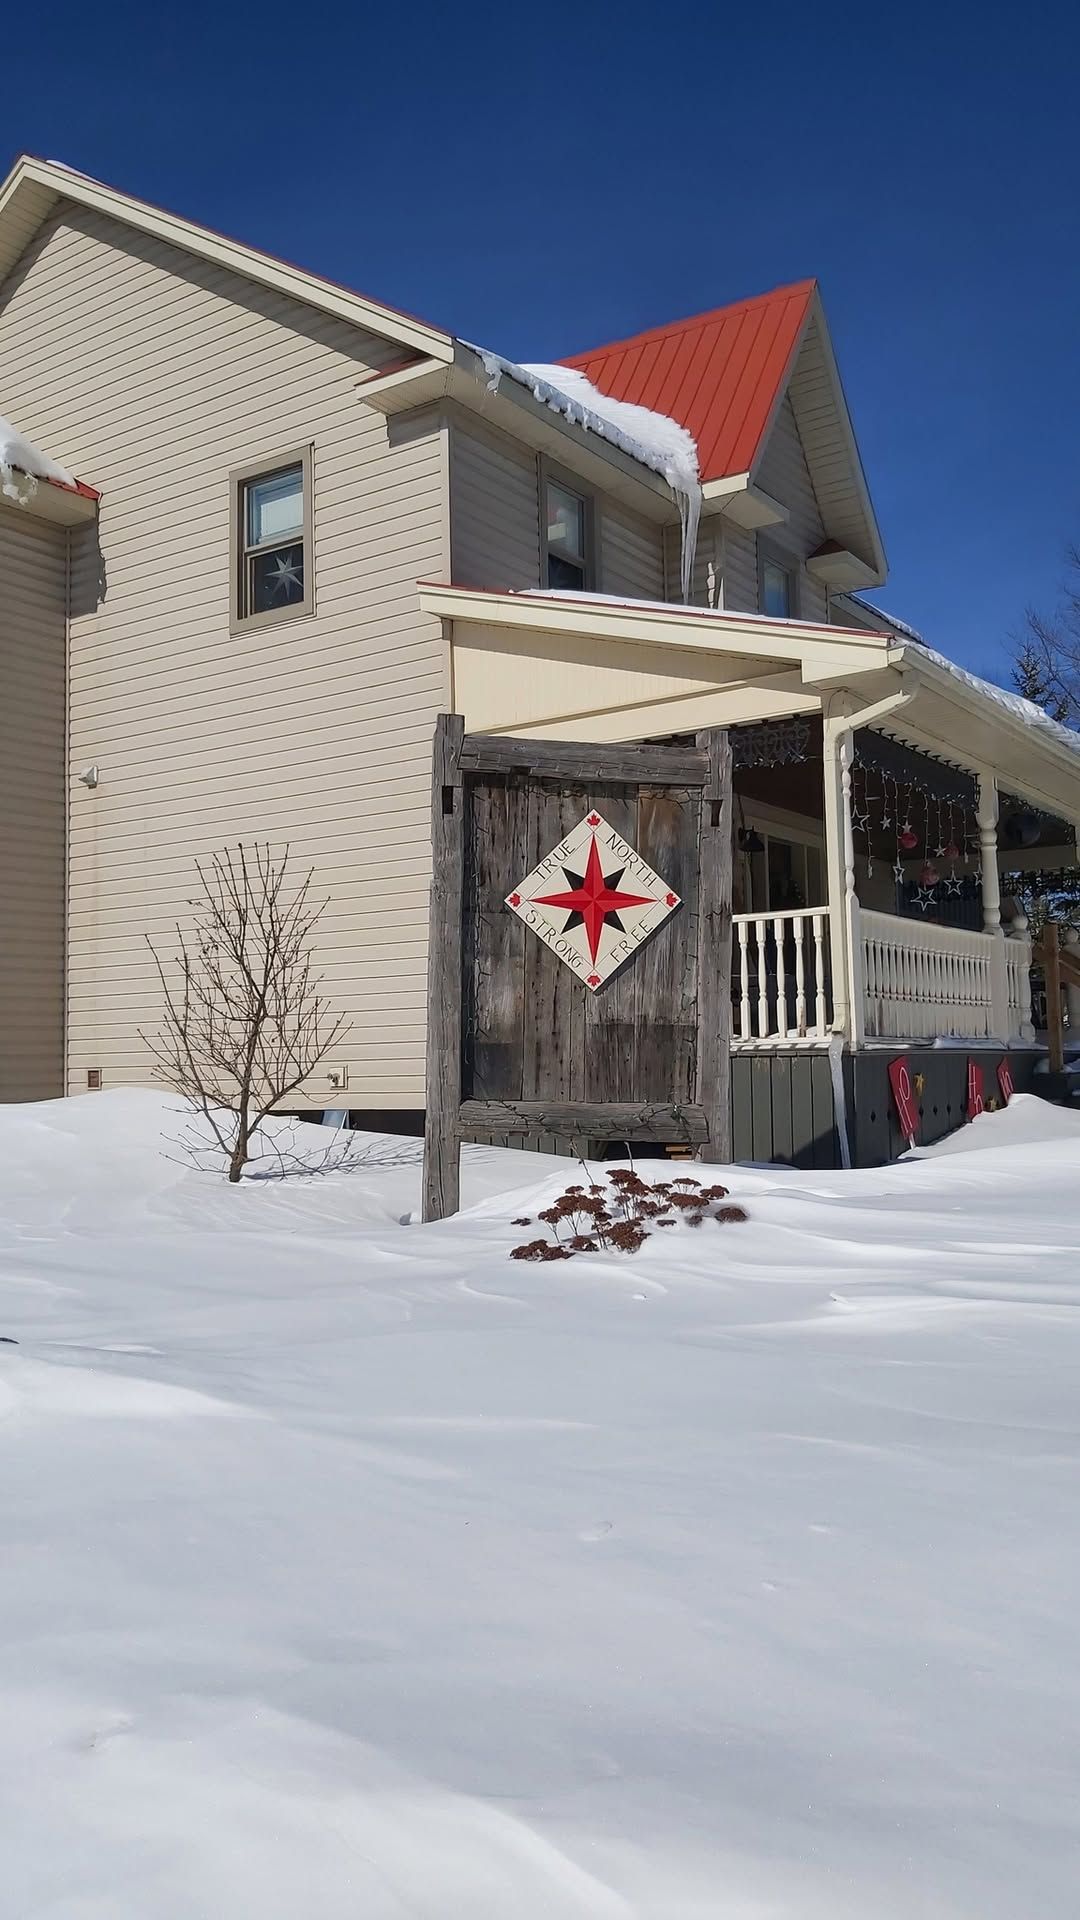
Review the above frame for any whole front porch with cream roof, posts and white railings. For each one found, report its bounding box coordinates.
[421,586,1080,1058]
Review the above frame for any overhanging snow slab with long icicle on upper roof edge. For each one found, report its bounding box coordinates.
[473,348,701,605]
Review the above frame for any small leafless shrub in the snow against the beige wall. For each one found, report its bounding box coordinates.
[142,847,348,1181]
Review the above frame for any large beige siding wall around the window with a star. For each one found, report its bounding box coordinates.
[0,205,450,1108]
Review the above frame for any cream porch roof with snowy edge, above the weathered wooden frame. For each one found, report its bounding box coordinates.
[421,582,1080,824]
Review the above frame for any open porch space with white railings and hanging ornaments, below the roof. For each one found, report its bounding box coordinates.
[732,718,1037,1052]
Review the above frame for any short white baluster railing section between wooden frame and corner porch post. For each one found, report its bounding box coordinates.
[732,906,830,1044]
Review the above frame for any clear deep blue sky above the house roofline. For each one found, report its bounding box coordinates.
[0,0,1080,678]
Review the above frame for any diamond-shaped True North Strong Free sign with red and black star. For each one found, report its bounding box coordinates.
[505,812,682,993]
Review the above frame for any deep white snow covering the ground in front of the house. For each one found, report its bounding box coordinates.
[0,1092,1080,1920]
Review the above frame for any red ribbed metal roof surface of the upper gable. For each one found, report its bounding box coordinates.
[563,280,817,480]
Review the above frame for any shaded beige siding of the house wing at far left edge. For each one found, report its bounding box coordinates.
[0,503,67,1100]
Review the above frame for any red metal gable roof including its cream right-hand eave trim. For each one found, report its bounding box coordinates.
[563,280,888,584]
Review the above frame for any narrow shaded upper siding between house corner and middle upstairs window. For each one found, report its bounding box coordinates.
[450,417,540,588]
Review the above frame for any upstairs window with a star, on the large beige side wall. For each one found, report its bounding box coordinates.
[233,453,313,626]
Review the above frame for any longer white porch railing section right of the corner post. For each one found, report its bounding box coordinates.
[857,910,1030,1041]
